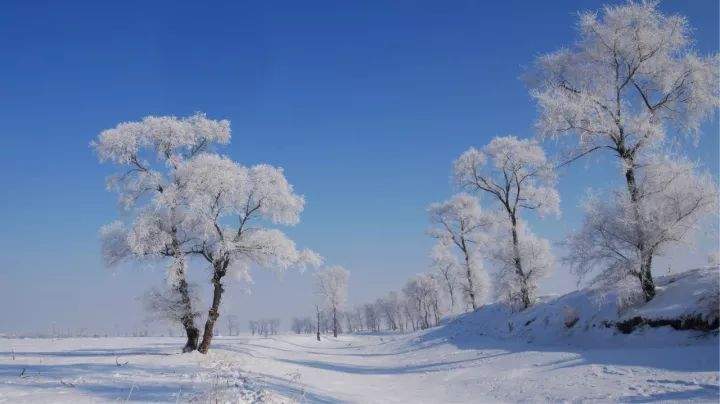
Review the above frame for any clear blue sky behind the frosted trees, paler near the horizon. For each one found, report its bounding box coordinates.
[0,0,718,332]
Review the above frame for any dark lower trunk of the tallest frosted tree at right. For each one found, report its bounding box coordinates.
[621,156,655,302]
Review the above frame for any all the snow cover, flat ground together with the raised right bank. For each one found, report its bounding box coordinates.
[0,268,720,403]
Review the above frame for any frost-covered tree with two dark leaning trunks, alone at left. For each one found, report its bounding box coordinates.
[92,114,320,353]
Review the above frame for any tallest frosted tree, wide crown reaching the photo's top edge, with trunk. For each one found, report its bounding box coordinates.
[530,1,720,300]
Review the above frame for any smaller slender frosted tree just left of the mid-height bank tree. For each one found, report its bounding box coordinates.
[428,194,490,310]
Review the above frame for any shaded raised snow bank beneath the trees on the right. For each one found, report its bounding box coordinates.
[438,267,720,346]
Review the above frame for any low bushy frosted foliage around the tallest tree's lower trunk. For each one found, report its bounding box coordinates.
[565,155,718,301]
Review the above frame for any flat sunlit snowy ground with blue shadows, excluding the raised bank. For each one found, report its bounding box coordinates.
[0,332,719,403]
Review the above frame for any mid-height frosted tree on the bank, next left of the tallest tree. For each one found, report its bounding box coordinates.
[454,136,560,309]
